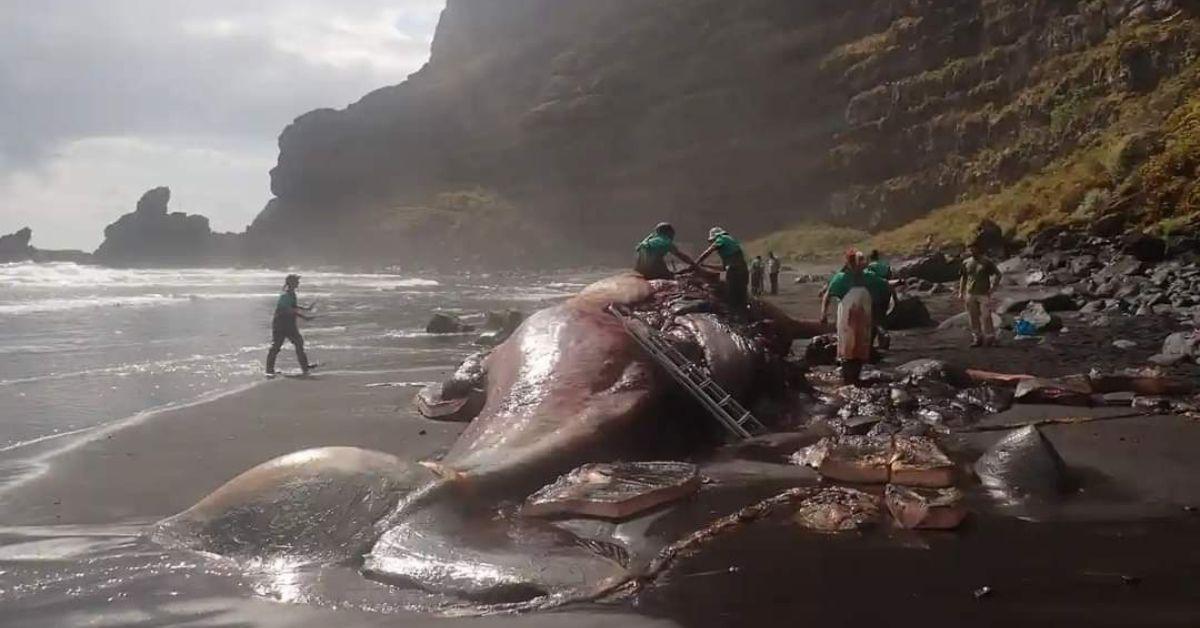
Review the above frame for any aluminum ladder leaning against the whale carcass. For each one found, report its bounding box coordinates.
[608,305,767,438]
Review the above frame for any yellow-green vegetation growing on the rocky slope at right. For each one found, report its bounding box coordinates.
[761,4,1200,257]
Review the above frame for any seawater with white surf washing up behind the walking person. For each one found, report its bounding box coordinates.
[0,264,587,457]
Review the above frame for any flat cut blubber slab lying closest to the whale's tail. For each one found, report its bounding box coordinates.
[521,462,700,519]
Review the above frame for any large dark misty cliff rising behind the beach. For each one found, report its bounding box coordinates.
[248,0,1200,263]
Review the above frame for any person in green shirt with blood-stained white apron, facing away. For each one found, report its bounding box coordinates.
[821,250,888,384]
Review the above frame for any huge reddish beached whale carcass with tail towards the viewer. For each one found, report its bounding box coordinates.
[156,274,805,599]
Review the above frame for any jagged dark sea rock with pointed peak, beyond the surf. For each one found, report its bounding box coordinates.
[95,187,240,267]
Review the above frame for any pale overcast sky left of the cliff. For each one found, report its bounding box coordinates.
[0,0,445,250]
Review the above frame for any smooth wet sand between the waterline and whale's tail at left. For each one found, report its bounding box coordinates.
[0,369,463,525]
